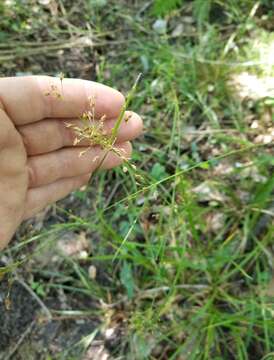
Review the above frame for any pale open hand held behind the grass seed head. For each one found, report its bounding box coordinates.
[0,76,142,250]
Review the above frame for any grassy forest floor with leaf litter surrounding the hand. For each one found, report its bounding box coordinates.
[0,0,274,360]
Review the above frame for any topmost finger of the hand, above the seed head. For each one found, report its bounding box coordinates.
[0,76,124,125]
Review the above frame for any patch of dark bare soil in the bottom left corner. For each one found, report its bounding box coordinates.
[0,281,103,360]
